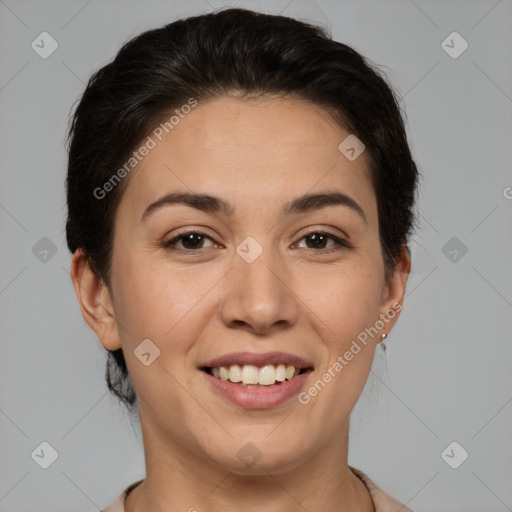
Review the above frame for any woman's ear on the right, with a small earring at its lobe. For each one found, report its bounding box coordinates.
[378,244,411,336]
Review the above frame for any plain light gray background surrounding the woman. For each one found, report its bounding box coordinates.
[0,0,512,512]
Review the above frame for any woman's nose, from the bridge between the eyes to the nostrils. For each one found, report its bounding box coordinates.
[221,243,300,336]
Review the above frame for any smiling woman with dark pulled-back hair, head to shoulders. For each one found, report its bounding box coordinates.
[66,9,418,512]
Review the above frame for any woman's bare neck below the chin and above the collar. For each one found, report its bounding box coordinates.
[125,412,374,512]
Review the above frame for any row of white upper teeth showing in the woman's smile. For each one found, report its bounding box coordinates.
[212,364,300,386]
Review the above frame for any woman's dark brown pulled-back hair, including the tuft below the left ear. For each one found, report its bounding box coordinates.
[66,9,418,410]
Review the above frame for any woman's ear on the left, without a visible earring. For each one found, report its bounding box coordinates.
[71,249,121,350]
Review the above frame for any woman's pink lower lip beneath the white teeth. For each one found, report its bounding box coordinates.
[200,370,312,409]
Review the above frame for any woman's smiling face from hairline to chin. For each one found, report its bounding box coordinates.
[75,97,409,473]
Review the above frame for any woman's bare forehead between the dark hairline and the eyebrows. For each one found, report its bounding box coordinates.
[118,97,375,224]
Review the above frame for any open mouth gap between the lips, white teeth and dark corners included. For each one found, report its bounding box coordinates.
[201,363,313,388]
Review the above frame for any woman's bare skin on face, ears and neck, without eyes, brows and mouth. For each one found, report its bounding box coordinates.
[72,97,410,512]
